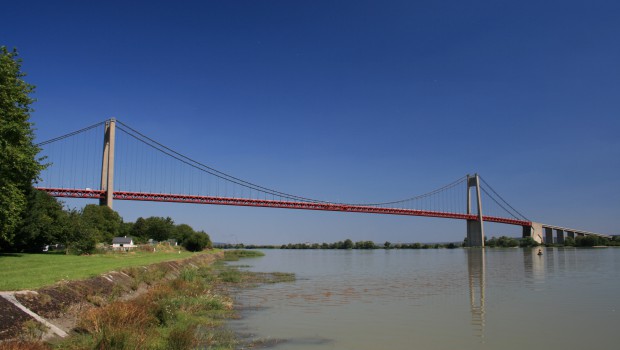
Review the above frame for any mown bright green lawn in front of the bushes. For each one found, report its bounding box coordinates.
[0,251,218,291]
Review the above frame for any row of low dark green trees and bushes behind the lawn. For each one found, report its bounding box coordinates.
[1,188,212,254]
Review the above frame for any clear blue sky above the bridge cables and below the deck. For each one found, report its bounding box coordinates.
[0,0,620,244]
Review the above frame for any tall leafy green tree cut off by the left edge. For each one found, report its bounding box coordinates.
[0,46,44,244]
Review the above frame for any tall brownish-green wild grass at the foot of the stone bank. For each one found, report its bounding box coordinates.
[55,267,237,350]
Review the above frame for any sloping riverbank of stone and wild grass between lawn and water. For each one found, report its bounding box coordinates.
[0,252,293,349]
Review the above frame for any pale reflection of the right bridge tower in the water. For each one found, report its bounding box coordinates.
[467,248,486,338]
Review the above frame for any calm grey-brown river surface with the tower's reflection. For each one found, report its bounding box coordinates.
[232,248,620,350]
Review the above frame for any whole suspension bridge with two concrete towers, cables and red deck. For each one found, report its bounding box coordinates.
[35,119,610,247]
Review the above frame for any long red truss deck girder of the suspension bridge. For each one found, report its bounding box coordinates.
[39,188,532,226]
